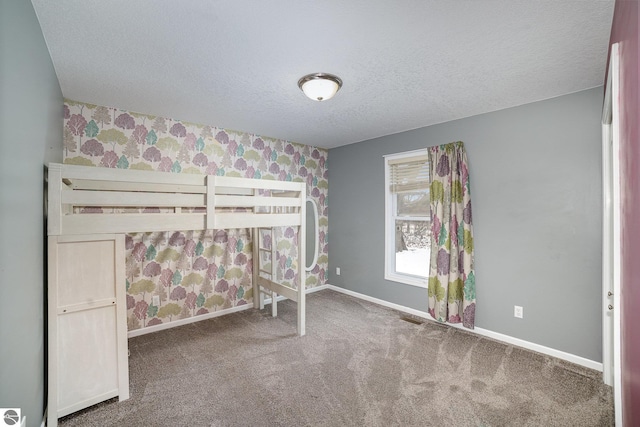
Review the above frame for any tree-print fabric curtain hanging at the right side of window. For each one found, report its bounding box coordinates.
[428,141,476,329]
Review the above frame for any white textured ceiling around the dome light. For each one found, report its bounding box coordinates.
[33,0,614,148]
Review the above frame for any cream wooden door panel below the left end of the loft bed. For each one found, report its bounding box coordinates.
[48,235,129,427]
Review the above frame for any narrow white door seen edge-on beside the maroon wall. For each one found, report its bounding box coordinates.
[602,43,622,426]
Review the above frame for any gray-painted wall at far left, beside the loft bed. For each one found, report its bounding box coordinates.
[0,0,63,426]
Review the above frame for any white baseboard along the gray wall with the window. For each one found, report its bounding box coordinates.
[323,285,602,372]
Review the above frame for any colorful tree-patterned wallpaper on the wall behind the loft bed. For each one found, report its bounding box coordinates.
[63,100,329,330]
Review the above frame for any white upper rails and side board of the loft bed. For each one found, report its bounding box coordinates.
[48,163,306,235]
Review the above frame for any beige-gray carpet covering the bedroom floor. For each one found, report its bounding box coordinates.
[60,290,614,427]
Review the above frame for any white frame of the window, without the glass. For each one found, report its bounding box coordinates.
[383,148,430,289]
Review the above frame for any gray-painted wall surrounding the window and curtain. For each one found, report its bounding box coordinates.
[329,87,603,362]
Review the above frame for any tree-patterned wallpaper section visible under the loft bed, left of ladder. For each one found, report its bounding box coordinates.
[125,229,253,331]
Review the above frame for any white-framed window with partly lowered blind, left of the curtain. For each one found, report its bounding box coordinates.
[385,149,431,287]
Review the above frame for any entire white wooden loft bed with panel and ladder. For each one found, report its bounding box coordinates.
[47,163,306,426]
